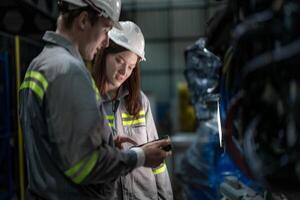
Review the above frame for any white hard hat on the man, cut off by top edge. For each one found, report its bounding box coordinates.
[62,0,121,29]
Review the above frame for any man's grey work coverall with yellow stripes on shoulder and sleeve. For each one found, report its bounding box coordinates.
[19,31,137,200]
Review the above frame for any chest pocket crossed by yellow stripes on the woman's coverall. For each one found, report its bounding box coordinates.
[122,110,148,144]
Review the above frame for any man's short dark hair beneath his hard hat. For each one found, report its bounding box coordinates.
[58,1,98,29]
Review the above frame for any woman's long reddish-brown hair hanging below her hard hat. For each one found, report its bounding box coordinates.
[92,40,142,116]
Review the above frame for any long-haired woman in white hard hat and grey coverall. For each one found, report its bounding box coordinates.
[93,21,173,200]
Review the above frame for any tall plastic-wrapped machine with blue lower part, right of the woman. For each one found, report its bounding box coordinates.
[175,38,252,200]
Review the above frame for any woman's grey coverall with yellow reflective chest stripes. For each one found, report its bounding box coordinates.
[102,88,173,200]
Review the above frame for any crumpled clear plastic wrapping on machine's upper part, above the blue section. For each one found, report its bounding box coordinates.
[184,38,222,120]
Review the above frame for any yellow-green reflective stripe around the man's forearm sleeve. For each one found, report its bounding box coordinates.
[65,151,99,184]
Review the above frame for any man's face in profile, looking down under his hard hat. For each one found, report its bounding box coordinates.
[79,17,113,61]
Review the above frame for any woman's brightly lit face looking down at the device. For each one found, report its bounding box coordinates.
[106,50,138,89]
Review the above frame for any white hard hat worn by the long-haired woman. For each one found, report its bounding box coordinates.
[108,21,146,60]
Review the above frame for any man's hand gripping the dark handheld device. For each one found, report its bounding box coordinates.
[141,139,172,168]
